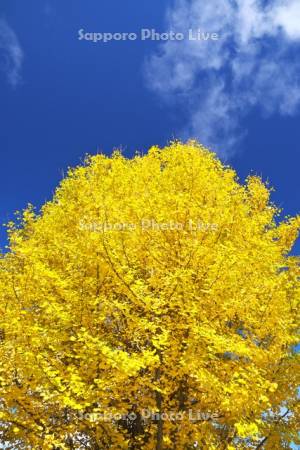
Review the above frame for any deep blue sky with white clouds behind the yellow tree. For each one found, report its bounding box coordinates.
[0,0,300,254]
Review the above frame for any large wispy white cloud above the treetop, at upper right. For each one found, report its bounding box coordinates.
[145,0,300,158]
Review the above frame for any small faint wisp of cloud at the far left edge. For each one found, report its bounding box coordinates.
[0,18,24,88]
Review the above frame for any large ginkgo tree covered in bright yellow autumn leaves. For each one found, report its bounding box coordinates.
[0,142,300,450]
